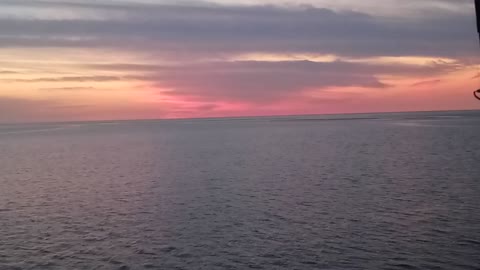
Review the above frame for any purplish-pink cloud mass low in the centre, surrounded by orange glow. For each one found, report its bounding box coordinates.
[150,61,387,103]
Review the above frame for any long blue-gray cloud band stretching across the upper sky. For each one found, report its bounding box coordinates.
[0,0,476,57]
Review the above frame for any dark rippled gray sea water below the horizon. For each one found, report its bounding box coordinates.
[0,112,480,270]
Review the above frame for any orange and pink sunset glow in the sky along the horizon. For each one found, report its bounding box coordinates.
[0,46,478,121]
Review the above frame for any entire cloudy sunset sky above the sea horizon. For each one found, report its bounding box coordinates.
[0,0,480,122]
